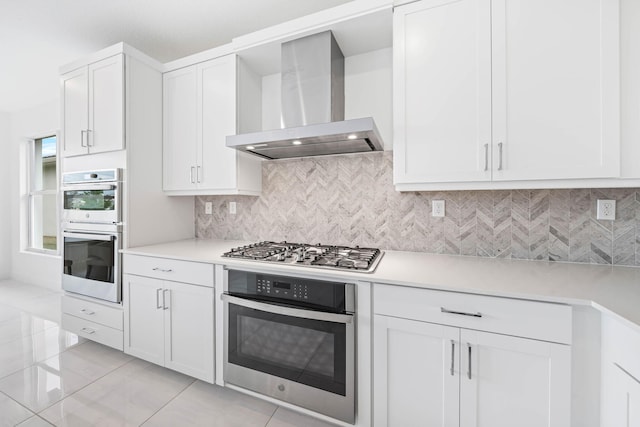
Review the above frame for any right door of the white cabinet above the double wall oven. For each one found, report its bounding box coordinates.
[87,54,124,153]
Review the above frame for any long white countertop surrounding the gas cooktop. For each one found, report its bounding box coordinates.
[123,239,640,332]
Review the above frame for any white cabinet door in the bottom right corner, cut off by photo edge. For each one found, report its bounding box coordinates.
[601,363,640,427]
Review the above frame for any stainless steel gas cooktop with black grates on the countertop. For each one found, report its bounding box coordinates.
[222,241,383,273]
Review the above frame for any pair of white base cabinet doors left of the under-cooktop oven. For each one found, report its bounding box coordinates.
[124,274,214,383]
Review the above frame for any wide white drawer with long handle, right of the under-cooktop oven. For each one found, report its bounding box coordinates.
[374,284,571,344]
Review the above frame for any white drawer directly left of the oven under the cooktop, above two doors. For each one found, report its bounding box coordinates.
[123,254,213,287]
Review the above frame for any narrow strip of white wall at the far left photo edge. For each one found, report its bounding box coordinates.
[0,113,11,280]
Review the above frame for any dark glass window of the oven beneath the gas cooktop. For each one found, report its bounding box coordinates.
[228,304,346,396]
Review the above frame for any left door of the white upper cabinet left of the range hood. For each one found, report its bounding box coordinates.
[162,66,198,190]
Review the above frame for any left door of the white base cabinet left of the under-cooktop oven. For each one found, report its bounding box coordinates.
[122,274,164,365]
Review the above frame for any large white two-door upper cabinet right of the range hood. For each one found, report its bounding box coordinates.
[394,0,620,190]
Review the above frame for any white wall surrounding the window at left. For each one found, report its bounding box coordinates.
[7,100,62,290]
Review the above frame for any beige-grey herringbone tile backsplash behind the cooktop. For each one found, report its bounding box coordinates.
[195,152,640,265]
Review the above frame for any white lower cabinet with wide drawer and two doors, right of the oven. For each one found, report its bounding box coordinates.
[373,285,571,427]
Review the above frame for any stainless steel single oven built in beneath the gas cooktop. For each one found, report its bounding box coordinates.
[222,269,355,424]
